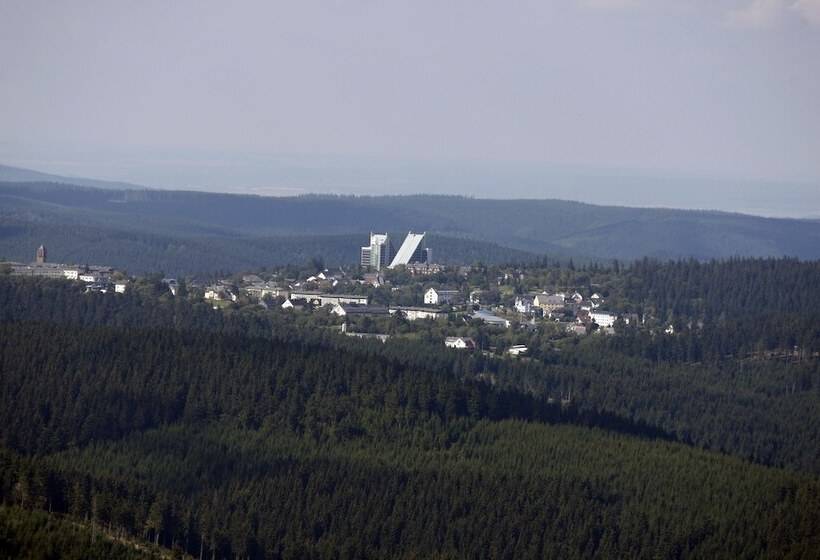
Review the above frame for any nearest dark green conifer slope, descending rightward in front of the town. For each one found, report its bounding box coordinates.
[0,279,820,559]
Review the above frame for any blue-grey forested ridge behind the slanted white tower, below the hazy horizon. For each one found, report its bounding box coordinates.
[0,183,820,272]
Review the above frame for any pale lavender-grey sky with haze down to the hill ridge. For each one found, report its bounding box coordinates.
[0,0,820,217]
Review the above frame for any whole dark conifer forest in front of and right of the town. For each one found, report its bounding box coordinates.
[0,259,820,558]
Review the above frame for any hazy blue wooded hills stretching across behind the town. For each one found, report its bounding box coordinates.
[0,182,820,273]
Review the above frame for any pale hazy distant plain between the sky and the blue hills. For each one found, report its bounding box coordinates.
[0,156,820,220]
